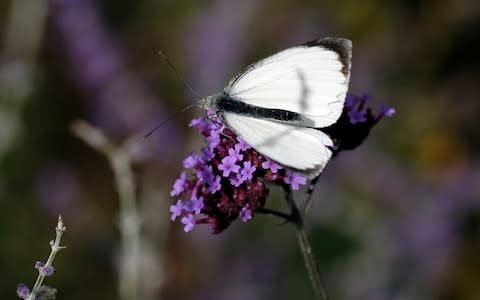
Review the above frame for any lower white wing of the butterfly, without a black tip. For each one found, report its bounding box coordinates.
[222,112,333,177]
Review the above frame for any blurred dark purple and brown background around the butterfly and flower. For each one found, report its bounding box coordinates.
[0,0,480,300]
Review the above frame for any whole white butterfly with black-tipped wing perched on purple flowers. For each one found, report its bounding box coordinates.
[199,38,352,177]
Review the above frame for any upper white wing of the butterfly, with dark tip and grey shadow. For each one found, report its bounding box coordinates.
[224,38,352,128]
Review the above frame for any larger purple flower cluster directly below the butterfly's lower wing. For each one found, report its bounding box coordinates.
[170,112,306,233]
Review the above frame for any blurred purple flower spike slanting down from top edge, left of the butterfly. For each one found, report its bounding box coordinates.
[48,0,182,162]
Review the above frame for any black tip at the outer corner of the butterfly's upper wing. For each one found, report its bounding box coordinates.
[302,37,352,77]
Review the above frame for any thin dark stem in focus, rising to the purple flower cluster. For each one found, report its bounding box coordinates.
[284,187,328,300]
